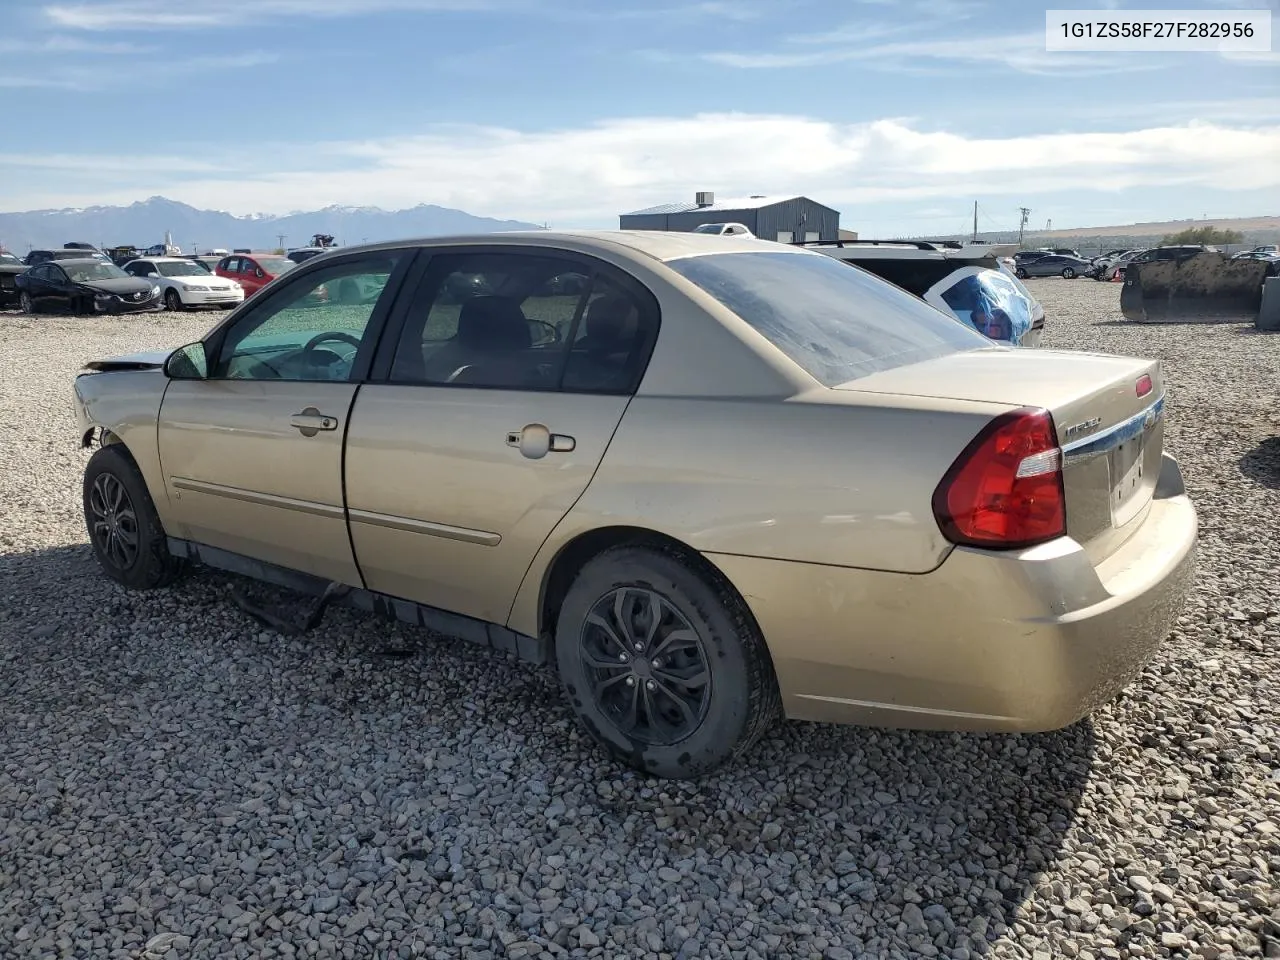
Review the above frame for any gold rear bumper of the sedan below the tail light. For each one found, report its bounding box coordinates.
[708,456,1197,731]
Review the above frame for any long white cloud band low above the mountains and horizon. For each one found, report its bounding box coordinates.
[0,114,1280,227]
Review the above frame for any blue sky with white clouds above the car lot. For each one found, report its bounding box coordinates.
[0,0,1280,236]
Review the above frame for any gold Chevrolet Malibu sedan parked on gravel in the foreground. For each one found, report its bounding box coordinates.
[76,233,1196,777]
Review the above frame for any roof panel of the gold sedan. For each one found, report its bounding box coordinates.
[325,230,820,262]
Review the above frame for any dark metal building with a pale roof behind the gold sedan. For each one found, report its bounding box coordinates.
[618,193,840,243]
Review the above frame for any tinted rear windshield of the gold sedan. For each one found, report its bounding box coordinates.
[667,252,992,387]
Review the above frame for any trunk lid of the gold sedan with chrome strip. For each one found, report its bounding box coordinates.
[837,348,1165,561]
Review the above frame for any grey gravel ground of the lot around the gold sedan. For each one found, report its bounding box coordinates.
[0,285,1280,960]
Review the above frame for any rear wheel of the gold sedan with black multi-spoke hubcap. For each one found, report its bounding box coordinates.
[556,545,781,778]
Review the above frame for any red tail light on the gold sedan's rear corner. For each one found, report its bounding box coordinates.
[933,410,1066,550]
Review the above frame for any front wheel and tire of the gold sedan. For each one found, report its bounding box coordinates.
[84,444,186,590]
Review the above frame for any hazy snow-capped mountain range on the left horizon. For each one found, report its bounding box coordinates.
[0,197,539,255]
